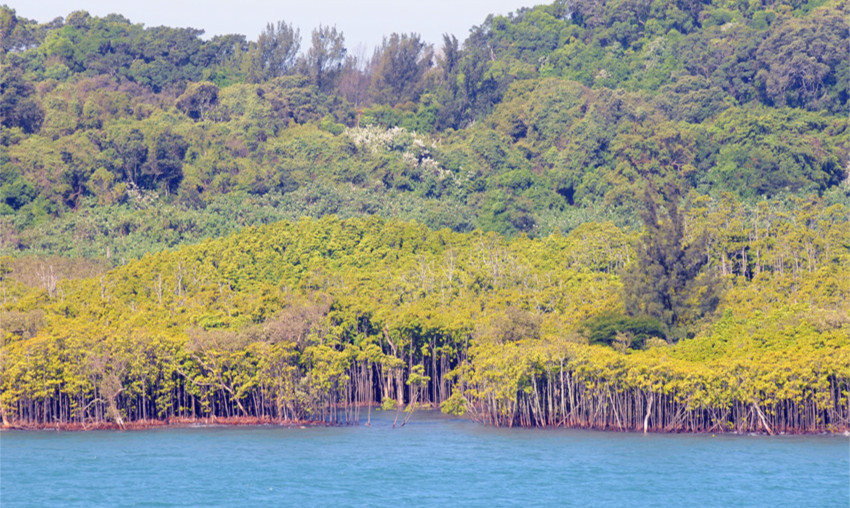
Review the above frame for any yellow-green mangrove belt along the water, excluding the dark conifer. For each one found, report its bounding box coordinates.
[0,203,850,430]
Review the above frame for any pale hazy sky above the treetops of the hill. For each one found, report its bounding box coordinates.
[8,0,536,50]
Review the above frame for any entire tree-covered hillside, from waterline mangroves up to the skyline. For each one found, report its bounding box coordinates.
[0,0,850,433]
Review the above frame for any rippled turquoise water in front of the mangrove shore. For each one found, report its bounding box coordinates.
[0,412,850,508]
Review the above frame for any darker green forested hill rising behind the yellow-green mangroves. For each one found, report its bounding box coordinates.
[0,1,850,264]
